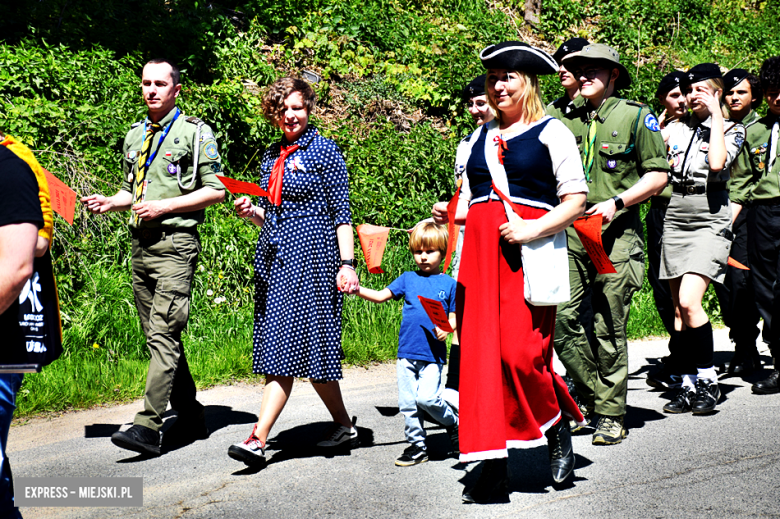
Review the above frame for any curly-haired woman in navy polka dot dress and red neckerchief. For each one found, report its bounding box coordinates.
[228,78,359,465]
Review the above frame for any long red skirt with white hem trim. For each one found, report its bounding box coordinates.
[456,201,584,462]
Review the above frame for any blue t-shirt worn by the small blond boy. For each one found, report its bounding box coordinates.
[387,272,457,364]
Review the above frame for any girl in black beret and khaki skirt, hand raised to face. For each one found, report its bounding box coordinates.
[660,63,745,414]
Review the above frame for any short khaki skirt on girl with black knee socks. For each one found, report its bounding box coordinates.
[658,191,732,283]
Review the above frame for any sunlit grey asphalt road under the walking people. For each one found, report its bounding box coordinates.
[8,330,780,519]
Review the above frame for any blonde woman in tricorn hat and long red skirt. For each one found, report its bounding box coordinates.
[433,41,588,503]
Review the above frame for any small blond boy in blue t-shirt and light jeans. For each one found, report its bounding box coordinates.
[358,222,458,467]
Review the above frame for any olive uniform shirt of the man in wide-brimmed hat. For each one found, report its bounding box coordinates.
[561,97,669,205]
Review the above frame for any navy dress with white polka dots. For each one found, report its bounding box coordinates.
[252,126,351,380]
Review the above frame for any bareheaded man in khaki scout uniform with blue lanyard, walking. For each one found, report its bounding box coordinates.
[81,60,225,456]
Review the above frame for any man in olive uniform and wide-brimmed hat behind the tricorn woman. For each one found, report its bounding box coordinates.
[555,44,669,445]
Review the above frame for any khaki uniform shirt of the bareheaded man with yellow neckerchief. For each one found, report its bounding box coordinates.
[122,108,225,229]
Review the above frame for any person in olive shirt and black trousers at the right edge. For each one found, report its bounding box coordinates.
[740,56,780,395]
